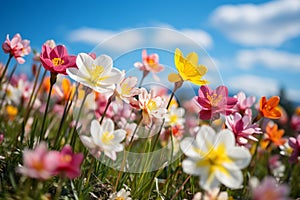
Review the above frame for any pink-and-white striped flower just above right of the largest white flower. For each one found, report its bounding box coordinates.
[226,113,262,145]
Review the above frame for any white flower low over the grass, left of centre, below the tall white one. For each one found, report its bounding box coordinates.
[80,119,126,160]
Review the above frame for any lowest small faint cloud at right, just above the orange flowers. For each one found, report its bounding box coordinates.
[228,75,279,97]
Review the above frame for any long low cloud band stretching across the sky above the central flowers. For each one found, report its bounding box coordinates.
[69,24,213,51]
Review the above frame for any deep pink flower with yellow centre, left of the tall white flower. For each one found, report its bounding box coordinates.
[40,44,76,75]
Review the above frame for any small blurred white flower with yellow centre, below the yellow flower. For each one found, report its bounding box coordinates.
[166,106,185,126]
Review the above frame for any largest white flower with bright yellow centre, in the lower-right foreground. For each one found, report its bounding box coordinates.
[180,126,251,190]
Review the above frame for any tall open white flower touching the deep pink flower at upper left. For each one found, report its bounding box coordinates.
[66,53,121,93]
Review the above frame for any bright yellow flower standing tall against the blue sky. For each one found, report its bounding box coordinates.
[168,48,209,85]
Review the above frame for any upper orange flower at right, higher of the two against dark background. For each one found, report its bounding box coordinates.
[259,96,281,119]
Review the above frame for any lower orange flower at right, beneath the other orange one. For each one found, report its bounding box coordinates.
[261,122,286,148]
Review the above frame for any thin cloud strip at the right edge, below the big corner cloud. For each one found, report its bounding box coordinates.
[236,49,300,71]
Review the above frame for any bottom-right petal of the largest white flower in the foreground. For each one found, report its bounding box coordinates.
[216,170,243,189]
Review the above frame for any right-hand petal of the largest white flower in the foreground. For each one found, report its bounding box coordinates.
[227,147,251,169]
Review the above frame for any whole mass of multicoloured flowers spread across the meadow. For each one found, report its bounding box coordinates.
[0,34,300,199]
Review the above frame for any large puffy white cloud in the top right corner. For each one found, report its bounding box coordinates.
[211,0,300,46]
